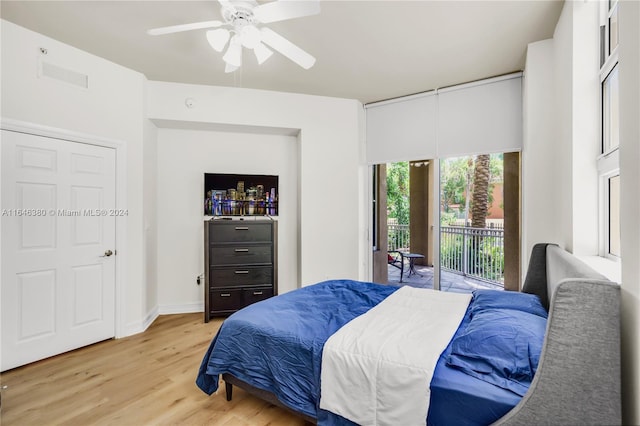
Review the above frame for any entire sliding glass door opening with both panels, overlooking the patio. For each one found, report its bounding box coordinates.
[372,153,520,292]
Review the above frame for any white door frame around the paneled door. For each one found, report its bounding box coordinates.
[0,118,127,338]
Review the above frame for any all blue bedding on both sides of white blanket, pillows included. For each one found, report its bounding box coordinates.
[196,280,546,426]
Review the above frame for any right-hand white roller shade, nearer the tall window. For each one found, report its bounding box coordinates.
[438,75,522,158]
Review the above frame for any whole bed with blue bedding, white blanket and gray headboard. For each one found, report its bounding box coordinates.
[196,244,620,425]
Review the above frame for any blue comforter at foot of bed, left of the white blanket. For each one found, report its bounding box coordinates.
[196,280,399,417]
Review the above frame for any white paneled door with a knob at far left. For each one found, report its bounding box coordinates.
[1,130,115,371]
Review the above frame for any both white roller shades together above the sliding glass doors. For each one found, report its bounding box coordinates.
[366,73,522,164]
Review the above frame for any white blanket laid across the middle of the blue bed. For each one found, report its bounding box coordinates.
[320,286,471,426]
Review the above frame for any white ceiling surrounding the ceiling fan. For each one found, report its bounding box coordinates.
[0,0,563,103]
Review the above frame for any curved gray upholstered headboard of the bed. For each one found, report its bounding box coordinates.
[495,244,621,426]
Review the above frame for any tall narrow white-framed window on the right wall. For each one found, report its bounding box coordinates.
[597,0,620,258]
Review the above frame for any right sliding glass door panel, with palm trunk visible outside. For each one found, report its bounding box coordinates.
[435,153,520,292]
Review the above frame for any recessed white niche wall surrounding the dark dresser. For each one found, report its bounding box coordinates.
[157,128,299,313]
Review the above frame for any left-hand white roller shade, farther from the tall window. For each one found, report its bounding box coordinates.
[366,91,436,164]
